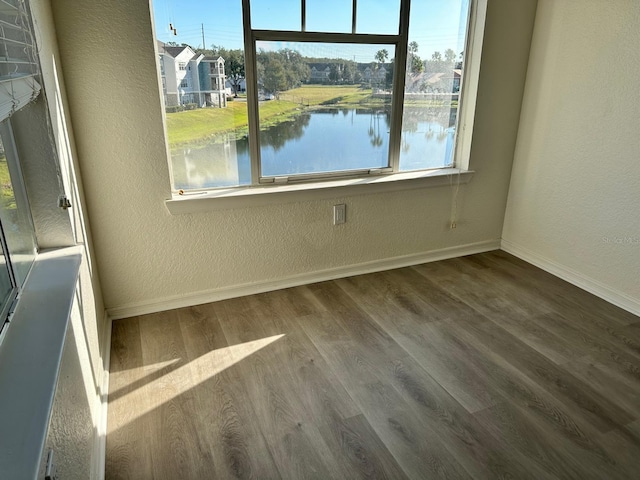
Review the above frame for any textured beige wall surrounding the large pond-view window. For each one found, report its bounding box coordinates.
[53,0,536,314]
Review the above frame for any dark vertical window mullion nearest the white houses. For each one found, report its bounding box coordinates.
[242,0,261,185]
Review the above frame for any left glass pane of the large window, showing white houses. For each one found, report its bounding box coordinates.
[154,1,251,190]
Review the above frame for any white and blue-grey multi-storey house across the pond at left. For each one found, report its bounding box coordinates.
[158,42,227,108]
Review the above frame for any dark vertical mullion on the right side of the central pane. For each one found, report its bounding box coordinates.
[389,0,410,172]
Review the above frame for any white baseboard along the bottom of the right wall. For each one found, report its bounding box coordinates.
[501,239,640,316]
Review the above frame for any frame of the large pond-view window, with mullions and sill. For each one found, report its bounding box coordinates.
[165,0,488,211]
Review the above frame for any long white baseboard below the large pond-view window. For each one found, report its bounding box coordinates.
[107,240,500,320]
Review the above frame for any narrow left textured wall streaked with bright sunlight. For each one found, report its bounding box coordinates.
[31,0,105,479]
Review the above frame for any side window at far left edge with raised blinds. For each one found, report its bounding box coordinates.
[0,1,40,344]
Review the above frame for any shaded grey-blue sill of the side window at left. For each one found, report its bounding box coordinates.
[0,247,82,478]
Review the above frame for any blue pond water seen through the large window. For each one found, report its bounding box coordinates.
[171,108,456,190]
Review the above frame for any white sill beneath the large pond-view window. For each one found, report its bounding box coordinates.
[165,168,473,215]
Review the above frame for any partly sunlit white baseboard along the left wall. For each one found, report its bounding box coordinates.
[91,311,111,480]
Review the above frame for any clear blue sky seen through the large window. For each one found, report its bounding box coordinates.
[152,0,469,62]
